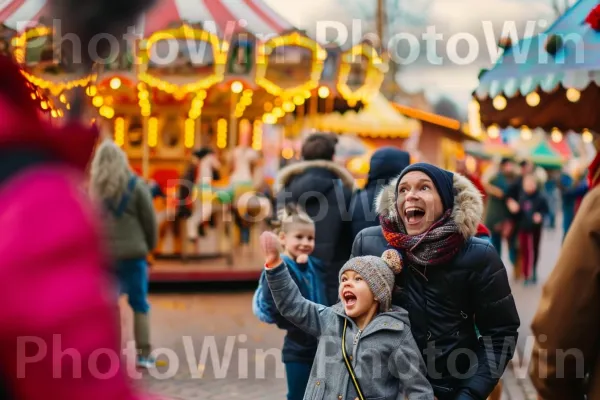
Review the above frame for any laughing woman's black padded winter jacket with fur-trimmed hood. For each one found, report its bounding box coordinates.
[352,175,520,400]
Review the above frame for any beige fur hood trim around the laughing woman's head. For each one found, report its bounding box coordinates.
[375,173,483,238]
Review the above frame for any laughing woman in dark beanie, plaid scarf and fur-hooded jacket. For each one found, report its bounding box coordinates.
[352,163,520,400]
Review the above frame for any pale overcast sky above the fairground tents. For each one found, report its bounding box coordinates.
[264,0,555,109]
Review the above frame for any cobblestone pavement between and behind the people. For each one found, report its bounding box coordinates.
[122,227,560,400]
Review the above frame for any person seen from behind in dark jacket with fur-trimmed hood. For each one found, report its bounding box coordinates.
[274,133,354,304]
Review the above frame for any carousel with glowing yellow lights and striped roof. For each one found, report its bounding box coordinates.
[0,0,386,280]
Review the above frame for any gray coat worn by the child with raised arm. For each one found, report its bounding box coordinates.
[266,263,434,400]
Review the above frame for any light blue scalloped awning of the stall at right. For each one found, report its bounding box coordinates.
[475,0,600,99]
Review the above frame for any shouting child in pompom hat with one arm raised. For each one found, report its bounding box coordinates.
[261,232,434,400]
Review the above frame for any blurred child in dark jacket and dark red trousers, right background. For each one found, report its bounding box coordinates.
[518,174,549,285]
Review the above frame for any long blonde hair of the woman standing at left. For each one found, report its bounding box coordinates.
[90,139,131,200]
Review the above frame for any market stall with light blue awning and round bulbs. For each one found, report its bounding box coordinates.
[472,0,600,168]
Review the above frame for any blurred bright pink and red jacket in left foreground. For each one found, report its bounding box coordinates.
[0,54,159,400]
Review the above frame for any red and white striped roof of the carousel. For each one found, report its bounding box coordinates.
[0,0,293,37]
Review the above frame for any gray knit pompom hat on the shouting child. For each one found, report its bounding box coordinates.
[339,249,402,312]
